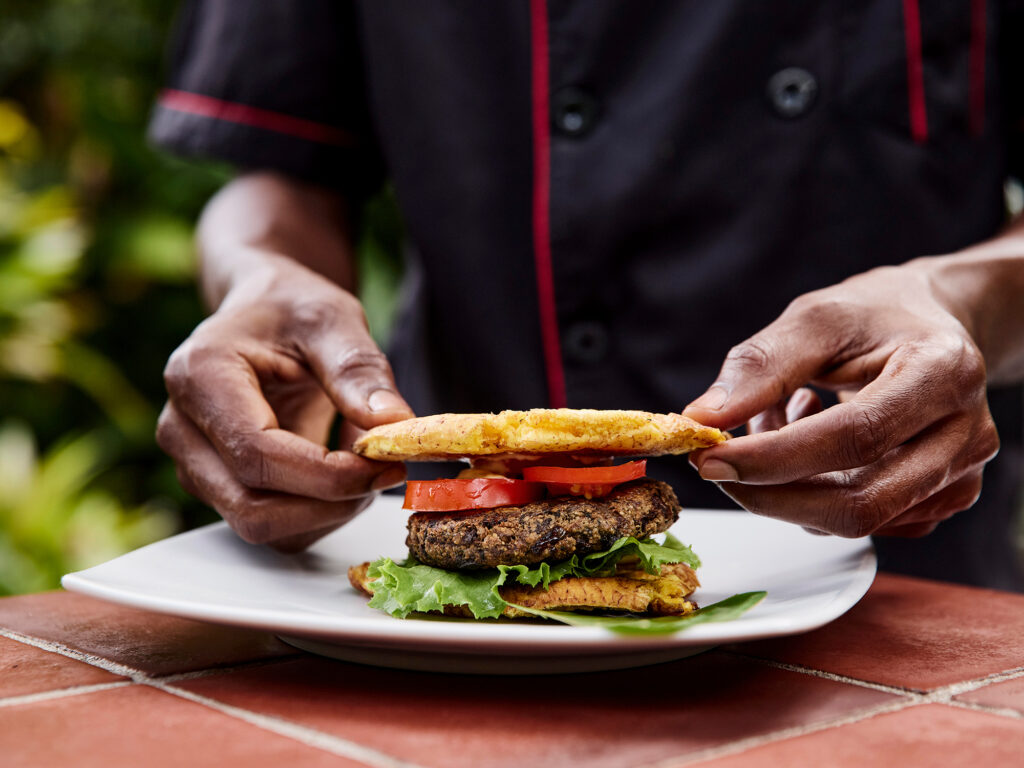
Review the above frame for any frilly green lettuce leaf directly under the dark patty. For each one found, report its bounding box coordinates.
[368,534,700,618]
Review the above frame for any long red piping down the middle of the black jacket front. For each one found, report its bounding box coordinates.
[529,0,566,408]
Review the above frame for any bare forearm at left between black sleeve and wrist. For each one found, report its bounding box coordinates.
[197,173,355,309]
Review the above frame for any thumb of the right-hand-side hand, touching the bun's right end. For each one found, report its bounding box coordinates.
[683,318,833,429]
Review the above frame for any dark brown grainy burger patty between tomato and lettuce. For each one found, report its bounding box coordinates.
[406,478,680,570]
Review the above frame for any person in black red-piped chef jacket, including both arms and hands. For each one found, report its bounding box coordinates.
[151,0,1024,589]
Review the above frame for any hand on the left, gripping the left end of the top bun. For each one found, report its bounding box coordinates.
[157,256,413,551]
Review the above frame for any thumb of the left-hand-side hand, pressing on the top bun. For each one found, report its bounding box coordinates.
[302,319,415,429]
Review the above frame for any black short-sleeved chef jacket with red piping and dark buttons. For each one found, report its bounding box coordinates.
[152,0,1024,588]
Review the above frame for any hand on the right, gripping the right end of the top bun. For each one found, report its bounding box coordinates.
[684,260,998,537]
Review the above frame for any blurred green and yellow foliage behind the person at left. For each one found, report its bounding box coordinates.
[0,0,401,595]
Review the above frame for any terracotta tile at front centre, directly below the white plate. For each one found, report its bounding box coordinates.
[176,653,897,768]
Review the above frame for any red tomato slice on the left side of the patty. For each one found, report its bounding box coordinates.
[402,477,544,512]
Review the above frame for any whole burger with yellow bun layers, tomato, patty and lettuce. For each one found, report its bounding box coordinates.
[349,409,727,618]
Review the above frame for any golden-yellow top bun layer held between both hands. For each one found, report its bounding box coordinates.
[352,409,726,461]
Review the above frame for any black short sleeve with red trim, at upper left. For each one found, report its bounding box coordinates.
[150,0,383,196]
